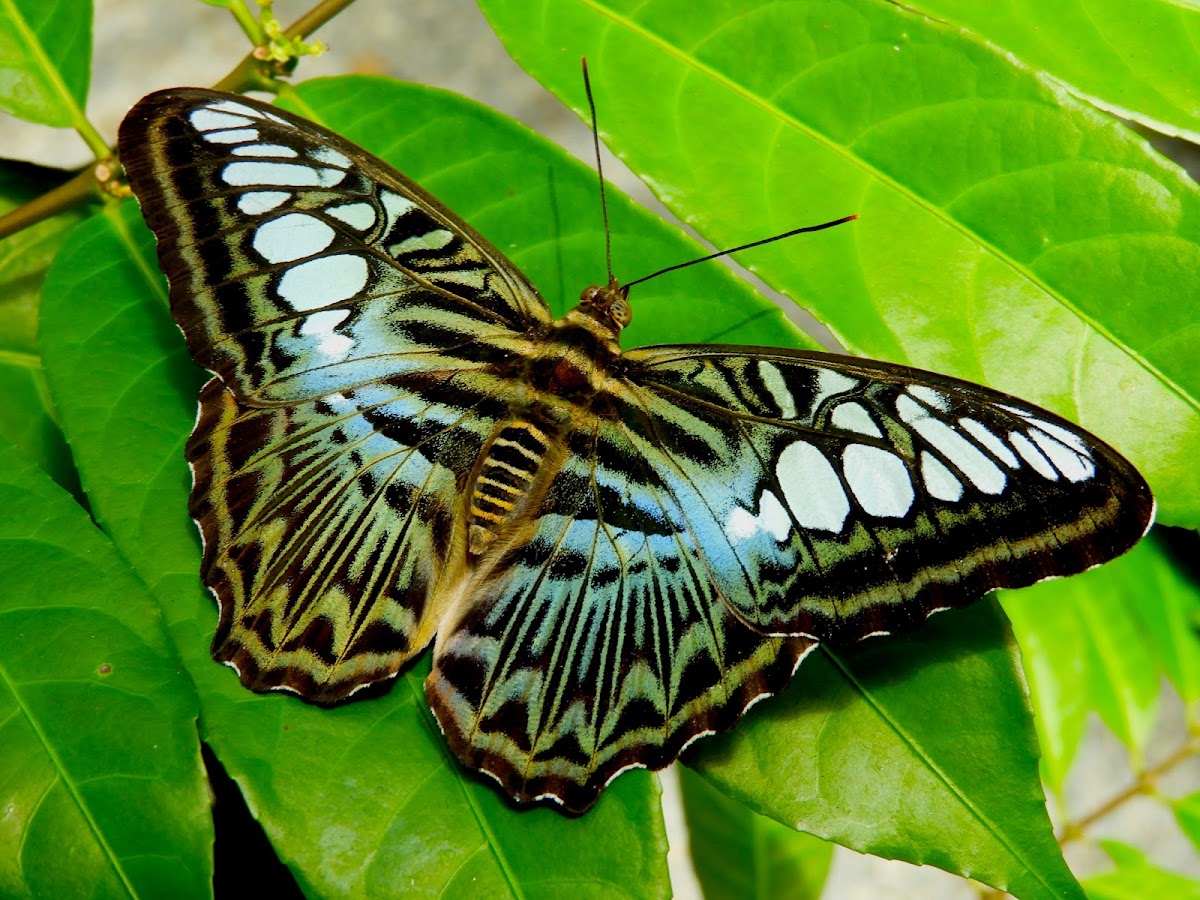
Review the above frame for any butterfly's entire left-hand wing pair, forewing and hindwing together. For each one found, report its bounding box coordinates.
[120,90,550,702]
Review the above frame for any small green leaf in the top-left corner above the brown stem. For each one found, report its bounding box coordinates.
[0,0,91,128]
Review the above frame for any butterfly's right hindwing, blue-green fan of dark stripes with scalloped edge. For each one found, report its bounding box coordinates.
[426,421,814,810]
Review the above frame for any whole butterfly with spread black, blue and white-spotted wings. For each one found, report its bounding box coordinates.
[120,89,1154,812]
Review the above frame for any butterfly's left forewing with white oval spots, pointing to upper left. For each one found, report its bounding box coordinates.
[121,90,550,403]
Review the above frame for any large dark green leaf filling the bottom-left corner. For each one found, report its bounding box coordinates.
[0,442,212,898]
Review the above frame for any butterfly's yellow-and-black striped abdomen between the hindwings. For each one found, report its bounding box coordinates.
[468,422,550,556]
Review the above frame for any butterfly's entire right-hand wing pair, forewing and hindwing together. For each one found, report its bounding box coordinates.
[426,347,1153,810]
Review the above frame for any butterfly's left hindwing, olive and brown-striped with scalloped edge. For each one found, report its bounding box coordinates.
[187,367,516,703]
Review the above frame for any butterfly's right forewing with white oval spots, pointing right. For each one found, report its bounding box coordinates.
[628,347,1154,641]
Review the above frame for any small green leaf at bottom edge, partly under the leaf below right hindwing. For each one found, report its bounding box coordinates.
[678,767,833,900]
